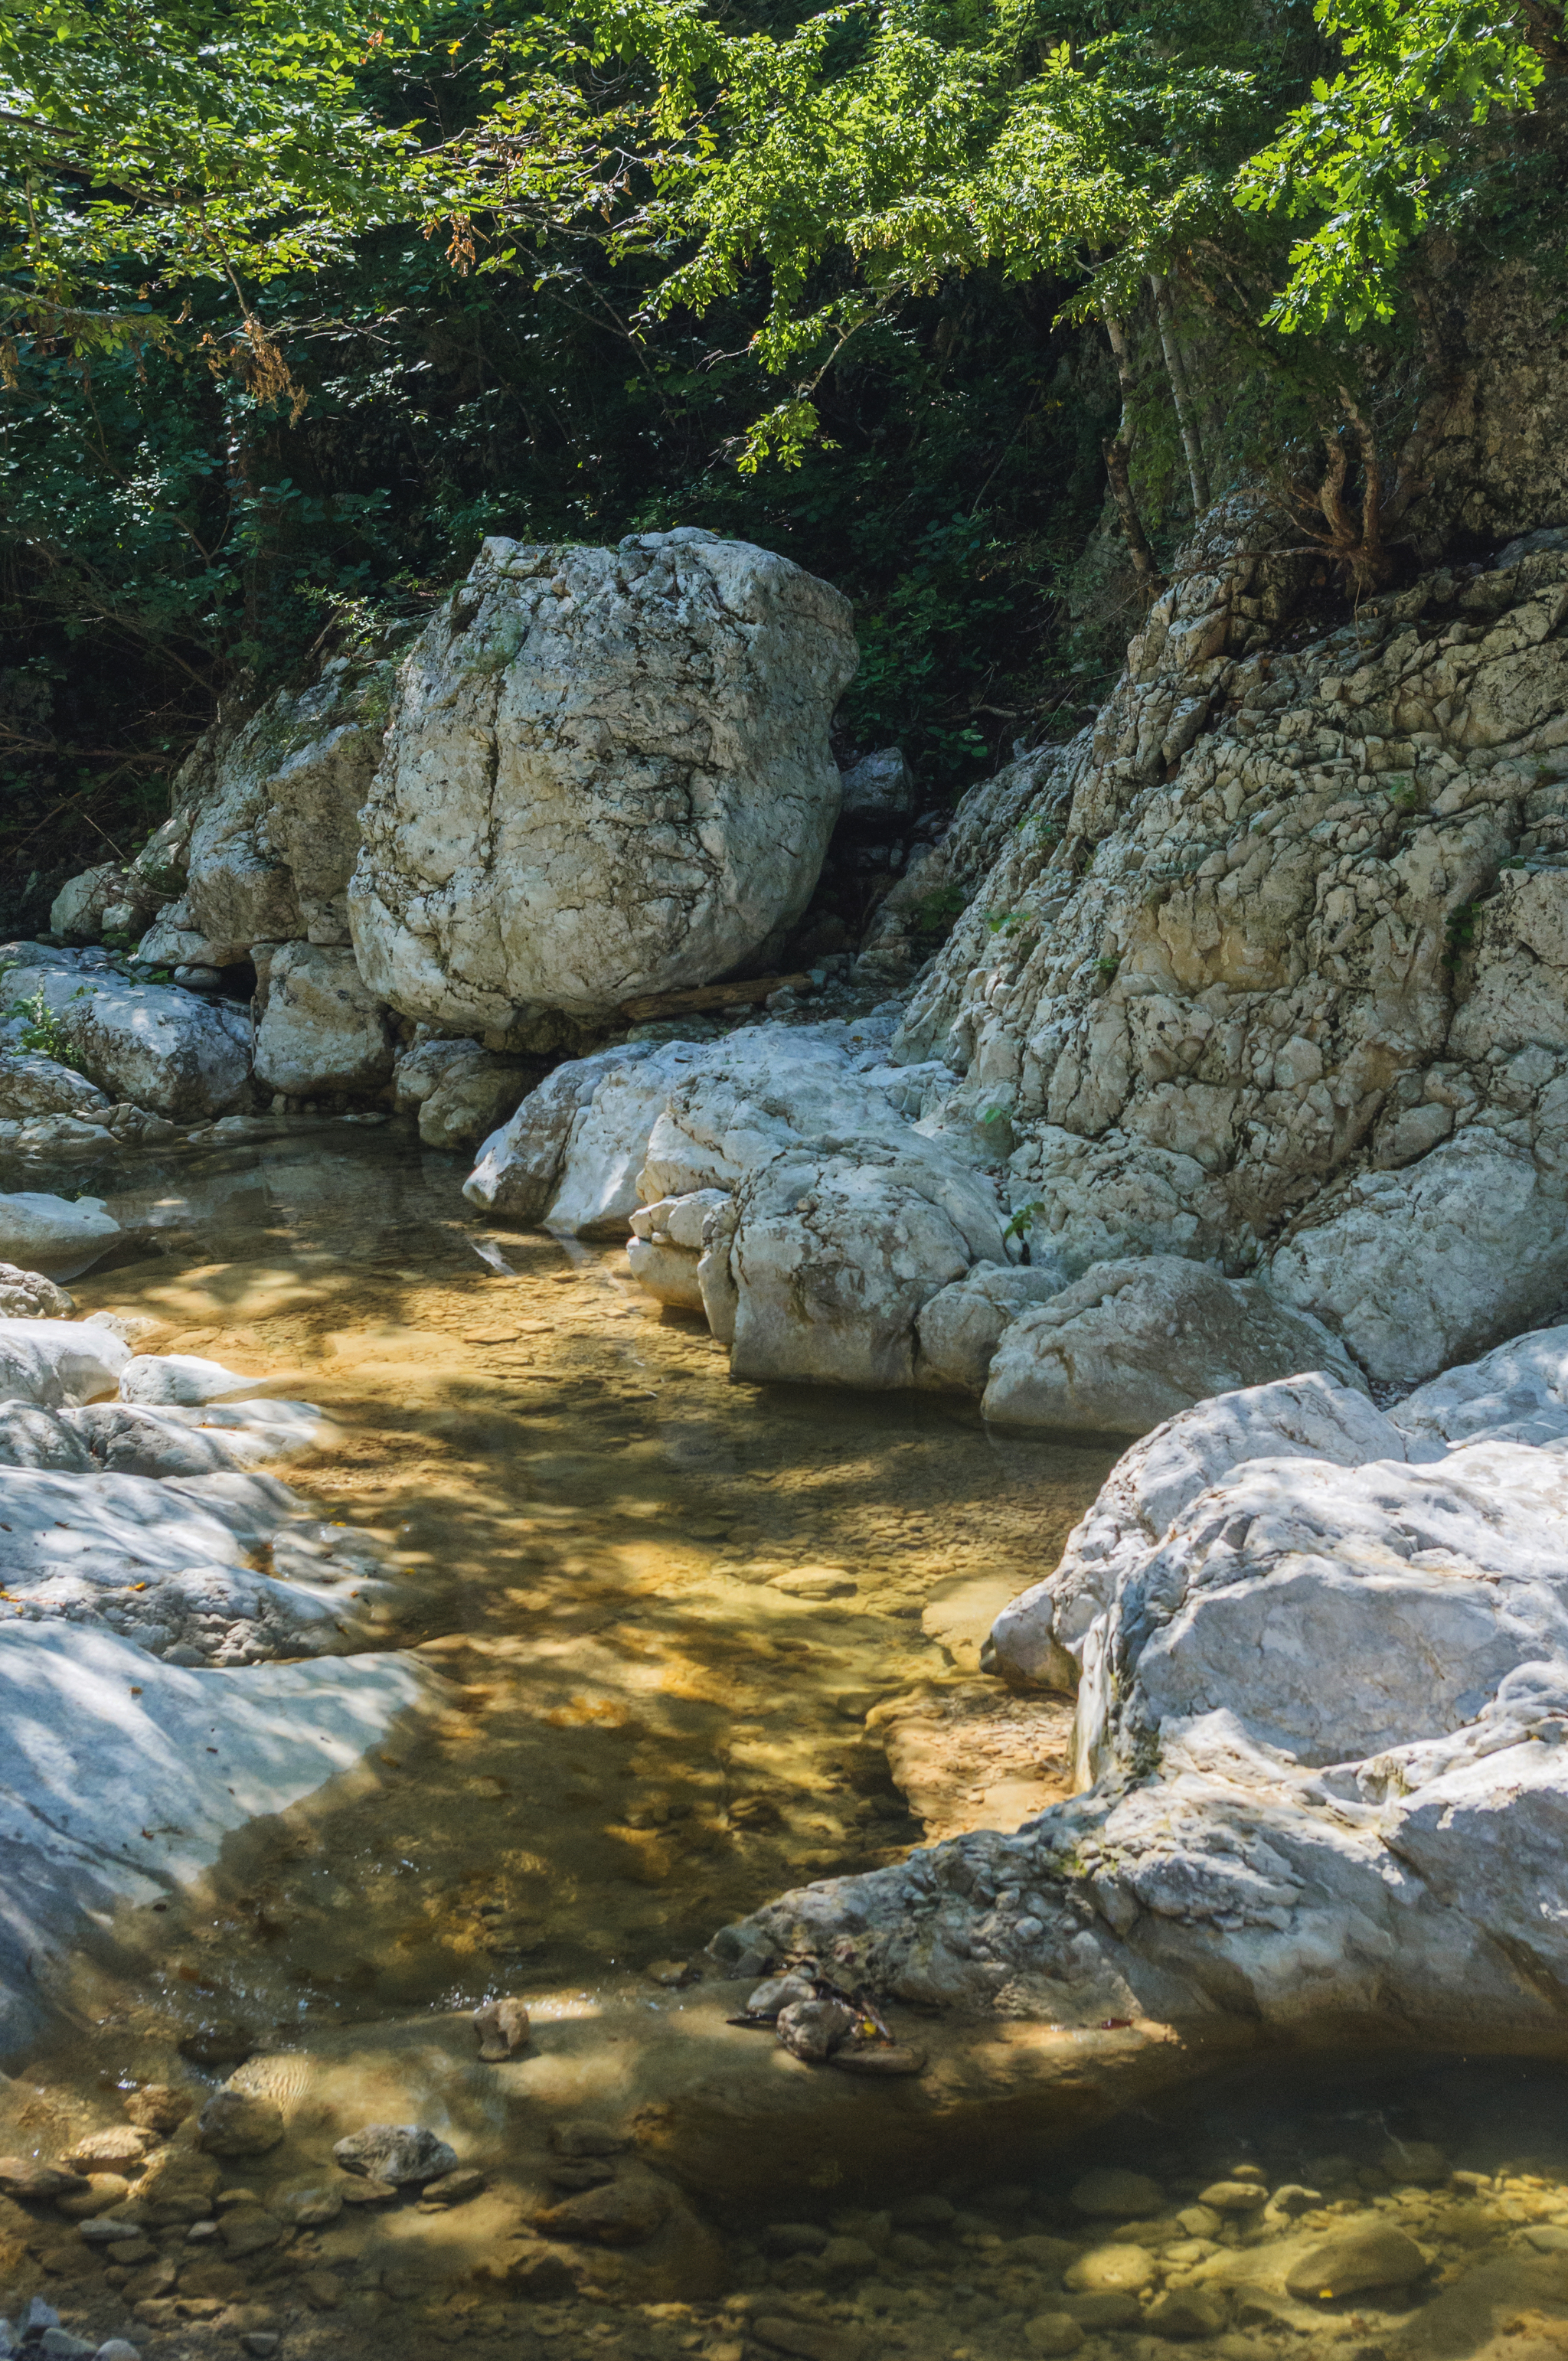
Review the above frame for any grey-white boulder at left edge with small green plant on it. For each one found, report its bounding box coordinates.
[5,945,250,1119]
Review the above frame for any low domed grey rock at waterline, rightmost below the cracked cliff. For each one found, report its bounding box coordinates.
[982,1254,1365,1433]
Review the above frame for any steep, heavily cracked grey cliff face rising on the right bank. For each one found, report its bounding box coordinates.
[895,508,1568,1383]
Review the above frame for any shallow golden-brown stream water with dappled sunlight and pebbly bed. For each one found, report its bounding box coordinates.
[0,1126,1568,2361]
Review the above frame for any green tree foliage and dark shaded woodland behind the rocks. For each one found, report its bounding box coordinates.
[0,0,1561,916]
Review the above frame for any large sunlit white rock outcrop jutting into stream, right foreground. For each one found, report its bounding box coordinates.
[716,1327,1568,2049]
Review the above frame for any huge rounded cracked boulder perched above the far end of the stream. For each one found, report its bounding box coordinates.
[349,529,858,1046]
